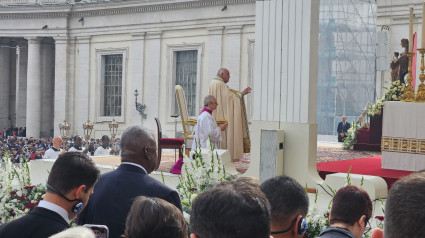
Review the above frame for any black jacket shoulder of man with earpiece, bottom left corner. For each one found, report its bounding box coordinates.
[0,207,69,238]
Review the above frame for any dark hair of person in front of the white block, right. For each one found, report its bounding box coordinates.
[330,185,372,226]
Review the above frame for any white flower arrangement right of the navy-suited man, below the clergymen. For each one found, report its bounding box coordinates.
[177,136,230,213]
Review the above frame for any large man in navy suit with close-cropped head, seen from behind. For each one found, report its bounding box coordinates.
[78,126,181,238]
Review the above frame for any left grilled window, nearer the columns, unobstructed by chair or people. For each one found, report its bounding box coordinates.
[103,54,123,116]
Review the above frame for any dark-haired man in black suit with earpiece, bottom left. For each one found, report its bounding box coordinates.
[0,152,100,238]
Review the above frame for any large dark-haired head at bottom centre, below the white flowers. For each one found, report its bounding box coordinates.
[190,181,270,238]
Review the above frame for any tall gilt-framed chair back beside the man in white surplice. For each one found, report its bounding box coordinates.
[175,85,196,156]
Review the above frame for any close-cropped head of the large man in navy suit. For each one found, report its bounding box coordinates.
[120,126,160,173]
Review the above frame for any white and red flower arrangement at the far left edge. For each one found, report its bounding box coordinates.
[0,153,46,225]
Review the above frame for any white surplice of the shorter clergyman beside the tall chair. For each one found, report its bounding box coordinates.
[192,111,222,151]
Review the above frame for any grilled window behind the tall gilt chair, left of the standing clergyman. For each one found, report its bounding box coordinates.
[174,50,198,116]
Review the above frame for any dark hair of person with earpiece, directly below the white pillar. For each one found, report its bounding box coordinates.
[260,176,309,222]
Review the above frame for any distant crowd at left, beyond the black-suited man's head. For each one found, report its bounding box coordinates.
[0,135,120,163]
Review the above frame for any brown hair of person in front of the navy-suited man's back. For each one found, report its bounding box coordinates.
[124,196,187,238]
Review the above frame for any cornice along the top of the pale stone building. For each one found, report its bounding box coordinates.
[0,0,255,19]
